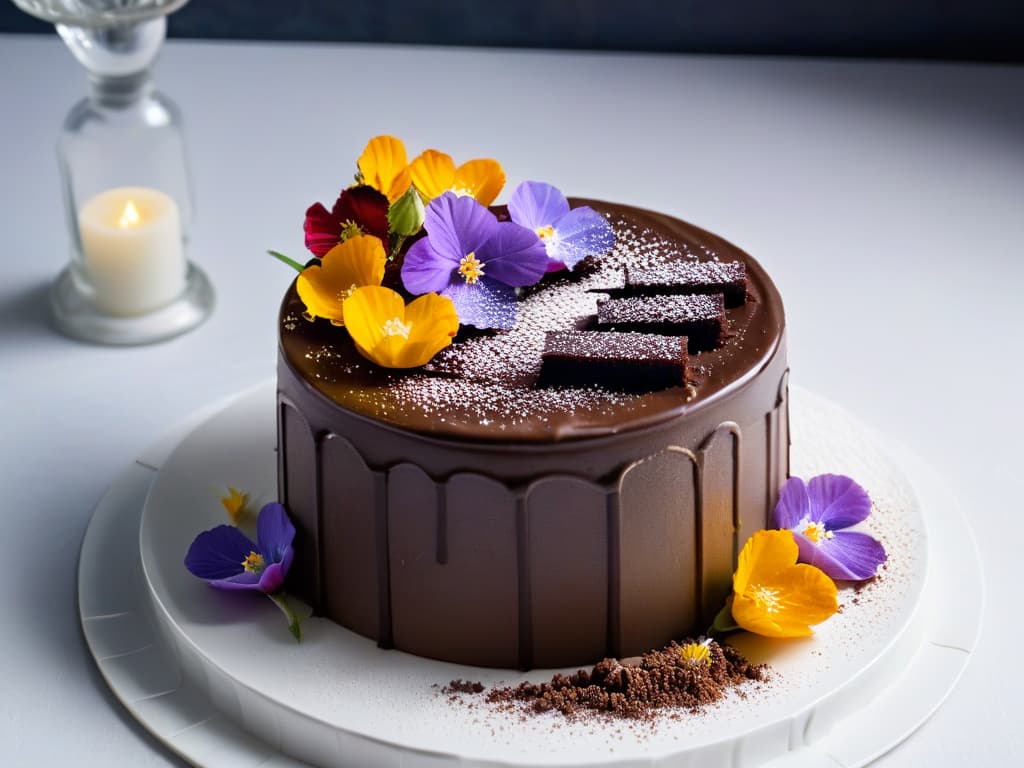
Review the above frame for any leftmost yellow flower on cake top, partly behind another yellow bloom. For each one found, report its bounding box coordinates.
[295,234,387,326]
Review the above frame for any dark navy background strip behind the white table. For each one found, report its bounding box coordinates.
[6,0,1024,61]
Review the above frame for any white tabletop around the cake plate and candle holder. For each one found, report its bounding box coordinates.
[0,35,1024,768]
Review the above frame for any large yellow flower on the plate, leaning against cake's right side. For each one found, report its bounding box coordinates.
[732,530,838,637]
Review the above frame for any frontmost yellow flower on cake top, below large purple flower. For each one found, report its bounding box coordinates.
[344,286,459,368]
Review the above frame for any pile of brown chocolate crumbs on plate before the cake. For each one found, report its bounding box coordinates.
[468,642,768,720]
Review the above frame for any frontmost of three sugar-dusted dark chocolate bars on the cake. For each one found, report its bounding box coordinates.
[538,331,687,391]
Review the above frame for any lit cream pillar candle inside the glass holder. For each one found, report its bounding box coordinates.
[78,186,185,316]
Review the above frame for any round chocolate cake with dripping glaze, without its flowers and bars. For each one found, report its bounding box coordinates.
[278,200,790,669]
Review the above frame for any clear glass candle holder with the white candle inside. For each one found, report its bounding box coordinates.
[14,0,213,344]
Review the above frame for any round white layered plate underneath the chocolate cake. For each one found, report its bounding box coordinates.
[79,382,981,768]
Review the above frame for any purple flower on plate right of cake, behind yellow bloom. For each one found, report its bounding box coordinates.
[772,475,886,581]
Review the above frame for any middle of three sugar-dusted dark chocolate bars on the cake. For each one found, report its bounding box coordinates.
[597,293,726,354]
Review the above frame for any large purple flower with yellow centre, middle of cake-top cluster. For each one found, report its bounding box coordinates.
[401,191,548,329]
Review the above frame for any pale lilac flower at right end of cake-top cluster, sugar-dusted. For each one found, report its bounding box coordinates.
[509,181,615,272]
